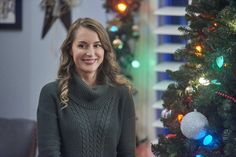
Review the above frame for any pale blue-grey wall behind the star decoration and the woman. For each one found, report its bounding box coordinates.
[0,0,106,119]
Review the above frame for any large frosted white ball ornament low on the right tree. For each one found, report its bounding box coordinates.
[180,111,208,140]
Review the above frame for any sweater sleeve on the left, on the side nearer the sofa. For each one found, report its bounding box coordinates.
[37,84,61,157]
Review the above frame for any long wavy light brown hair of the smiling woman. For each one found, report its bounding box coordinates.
[58,18,133,106]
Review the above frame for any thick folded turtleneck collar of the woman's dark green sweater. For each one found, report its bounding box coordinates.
[69,72,108,102]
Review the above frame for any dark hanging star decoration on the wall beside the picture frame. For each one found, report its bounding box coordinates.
[41,0,71,39]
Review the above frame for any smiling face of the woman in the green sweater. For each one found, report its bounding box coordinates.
[71,27,104,75]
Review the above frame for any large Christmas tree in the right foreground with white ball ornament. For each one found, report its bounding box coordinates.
[152,0,236,157]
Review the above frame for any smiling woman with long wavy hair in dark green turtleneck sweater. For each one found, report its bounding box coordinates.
[37,18,135,157]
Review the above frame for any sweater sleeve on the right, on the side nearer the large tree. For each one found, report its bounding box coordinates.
[117,87,136,157]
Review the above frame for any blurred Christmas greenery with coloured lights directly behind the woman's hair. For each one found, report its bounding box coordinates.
[104,0,141,80]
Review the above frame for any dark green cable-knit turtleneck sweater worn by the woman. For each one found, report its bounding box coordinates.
[37,74,135,157]
